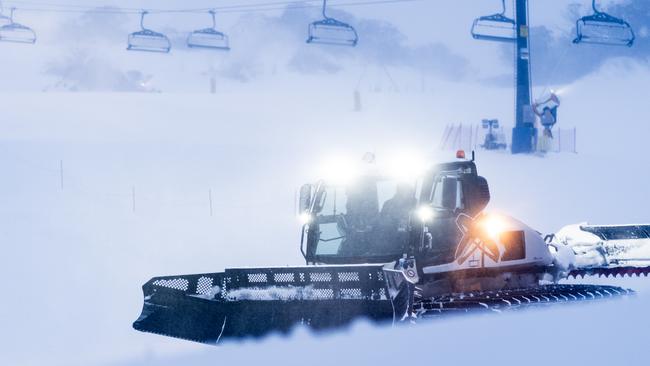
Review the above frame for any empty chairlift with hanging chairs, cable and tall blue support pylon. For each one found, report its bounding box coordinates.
[0,0,635,154]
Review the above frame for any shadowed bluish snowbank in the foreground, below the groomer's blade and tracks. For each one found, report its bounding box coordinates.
[115,286,648,366]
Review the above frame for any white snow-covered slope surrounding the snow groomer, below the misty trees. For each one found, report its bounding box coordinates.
[0,60,650,365]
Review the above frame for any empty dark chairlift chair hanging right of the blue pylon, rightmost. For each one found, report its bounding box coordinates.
[573,0,635,47]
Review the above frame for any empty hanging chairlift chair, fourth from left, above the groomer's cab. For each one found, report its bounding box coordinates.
[307,0,359,47]
